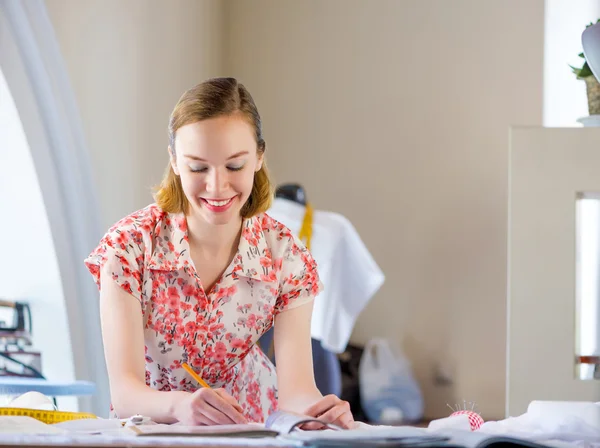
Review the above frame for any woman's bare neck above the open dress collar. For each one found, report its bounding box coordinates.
[186,214,242,259]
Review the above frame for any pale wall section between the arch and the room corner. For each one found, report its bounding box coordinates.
[46,0,223,231]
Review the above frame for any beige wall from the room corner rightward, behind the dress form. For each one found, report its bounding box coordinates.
[225,0,544,419]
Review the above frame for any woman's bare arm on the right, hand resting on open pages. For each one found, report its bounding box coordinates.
[273,301,354,428]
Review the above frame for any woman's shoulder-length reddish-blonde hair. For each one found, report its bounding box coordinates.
[154,78,273,218]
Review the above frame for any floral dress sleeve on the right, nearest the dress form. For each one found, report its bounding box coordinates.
[275,239,323,313]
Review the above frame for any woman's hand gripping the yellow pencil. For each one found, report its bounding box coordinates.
[173,387,248,425]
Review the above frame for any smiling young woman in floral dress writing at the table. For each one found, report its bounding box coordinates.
[85,78,353,428]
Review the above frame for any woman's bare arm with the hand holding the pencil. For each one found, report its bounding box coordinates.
[100,269,246,425]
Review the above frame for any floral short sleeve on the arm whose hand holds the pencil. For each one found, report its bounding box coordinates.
[84,223,144,304]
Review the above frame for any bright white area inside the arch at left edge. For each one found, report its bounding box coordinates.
[0,67,77,410]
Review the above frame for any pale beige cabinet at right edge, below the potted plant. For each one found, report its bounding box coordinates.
[507,128,600,416]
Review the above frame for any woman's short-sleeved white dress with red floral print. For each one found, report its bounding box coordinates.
[85,204,322,422]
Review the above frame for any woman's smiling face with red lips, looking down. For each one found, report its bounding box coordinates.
[169,116,263,225]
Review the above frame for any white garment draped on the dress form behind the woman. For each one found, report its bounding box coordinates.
[267,198,385,353]
